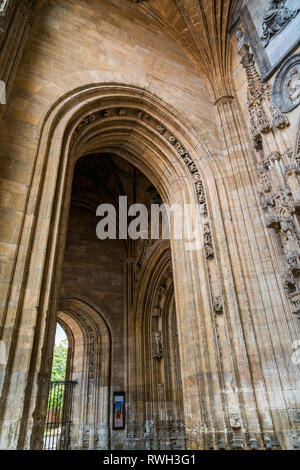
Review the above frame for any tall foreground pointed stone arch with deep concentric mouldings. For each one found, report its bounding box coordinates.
[0,83,294,449]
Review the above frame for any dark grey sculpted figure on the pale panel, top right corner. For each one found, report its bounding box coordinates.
[261,0,300,47]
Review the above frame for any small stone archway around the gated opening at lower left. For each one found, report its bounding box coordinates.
[58,299,111,449]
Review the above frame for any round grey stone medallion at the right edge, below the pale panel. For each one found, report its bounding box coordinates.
[272,54,300,113]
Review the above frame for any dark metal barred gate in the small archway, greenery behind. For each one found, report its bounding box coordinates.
[44,381,76,450]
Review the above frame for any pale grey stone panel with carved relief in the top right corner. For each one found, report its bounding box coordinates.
[240,0,300,80]
